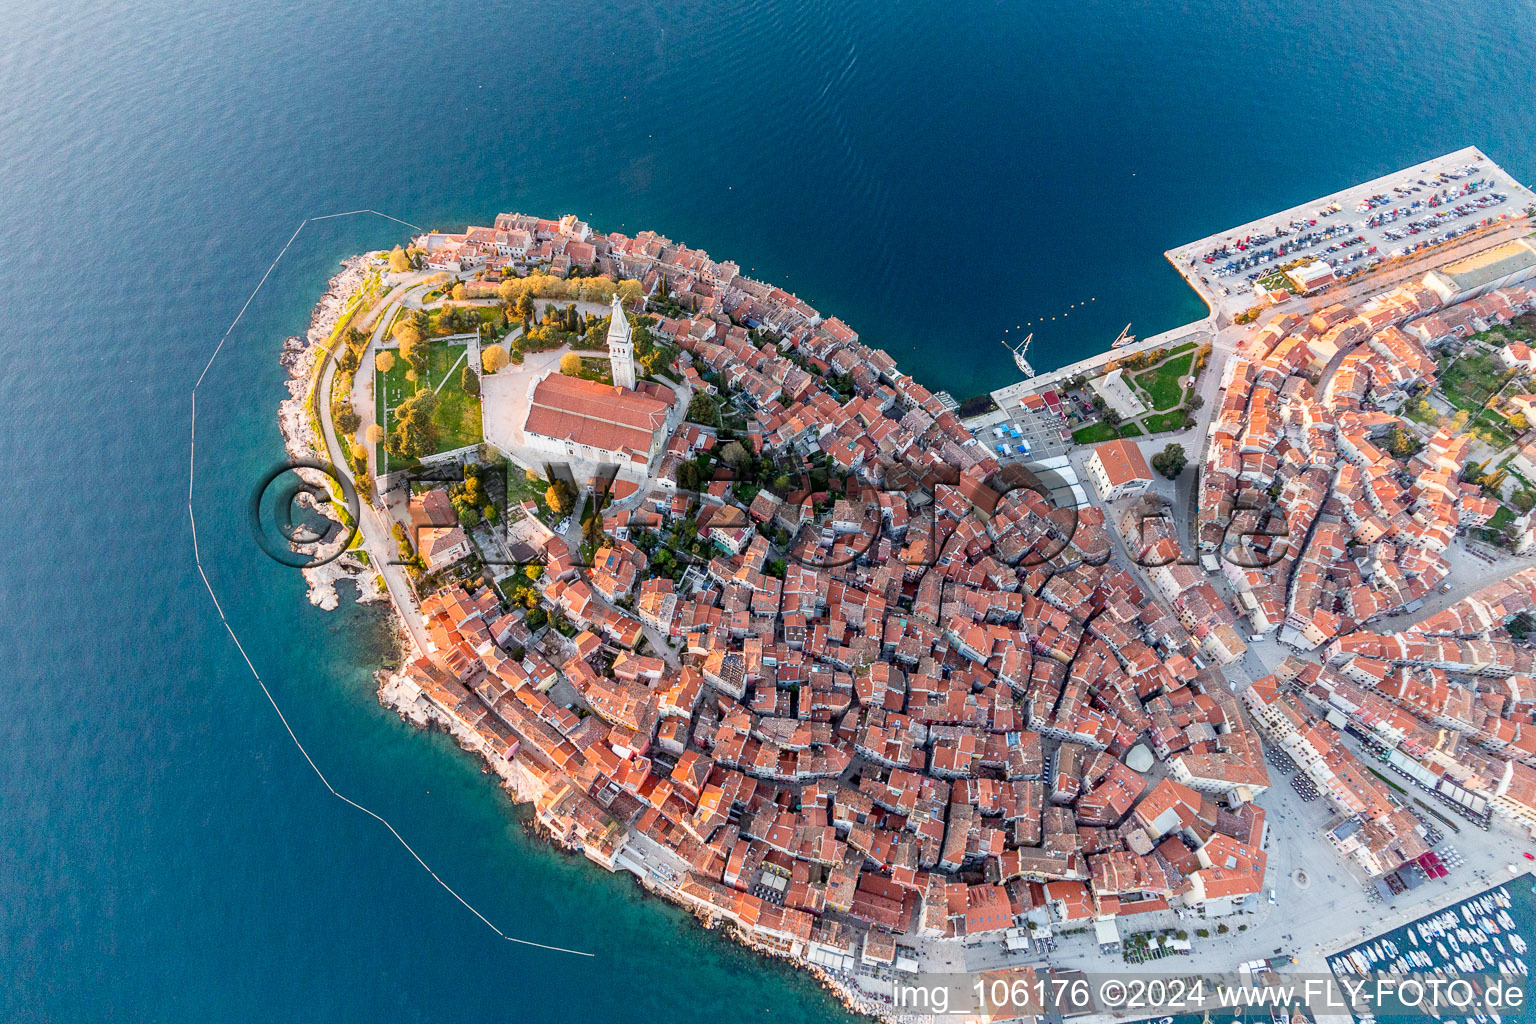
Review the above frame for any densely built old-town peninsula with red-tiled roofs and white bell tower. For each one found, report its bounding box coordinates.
[283,149,1536,1016]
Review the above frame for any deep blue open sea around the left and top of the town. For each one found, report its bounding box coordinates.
[0,0,1536,1024]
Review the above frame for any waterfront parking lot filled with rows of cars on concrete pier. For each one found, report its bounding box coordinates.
[1164,146,1536,315]
